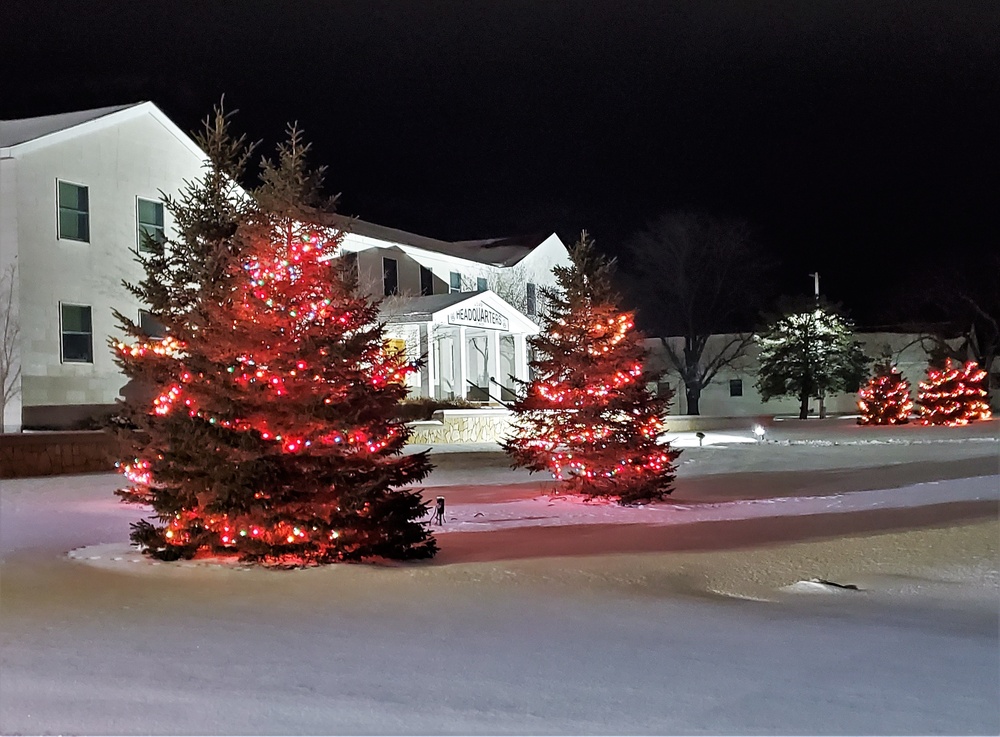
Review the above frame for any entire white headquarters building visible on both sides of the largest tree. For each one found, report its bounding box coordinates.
[0,102,569,432]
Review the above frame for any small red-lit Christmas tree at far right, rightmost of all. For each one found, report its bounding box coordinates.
[917,358,992,425]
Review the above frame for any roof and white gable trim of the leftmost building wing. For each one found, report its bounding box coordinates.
[0,102,205,157]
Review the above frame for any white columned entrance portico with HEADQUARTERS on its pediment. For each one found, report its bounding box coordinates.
[382,291,538,403]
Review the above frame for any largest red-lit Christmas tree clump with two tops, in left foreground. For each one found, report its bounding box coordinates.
[113,111,436,565]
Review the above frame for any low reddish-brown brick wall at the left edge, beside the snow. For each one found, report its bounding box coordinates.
[0,430,115,479]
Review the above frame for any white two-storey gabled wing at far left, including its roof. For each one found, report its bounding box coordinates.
[0,102,205,431]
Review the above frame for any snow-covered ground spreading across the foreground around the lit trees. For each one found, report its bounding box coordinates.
[0,416,1000,734]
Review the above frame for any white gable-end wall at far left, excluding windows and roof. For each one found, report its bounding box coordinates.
[0,105,203,422]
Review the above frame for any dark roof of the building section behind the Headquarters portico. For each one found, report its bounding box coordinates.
[328,215,548,266]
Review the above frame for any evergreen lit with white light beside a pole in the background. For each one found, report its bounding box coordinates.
[757,304,871,420]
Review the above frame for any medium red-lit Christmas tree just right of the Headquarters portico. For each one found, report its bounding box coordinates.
[504,232,680,504]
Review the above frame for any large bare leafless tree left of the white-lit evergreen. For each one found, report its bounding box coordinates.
[626,212,767,415]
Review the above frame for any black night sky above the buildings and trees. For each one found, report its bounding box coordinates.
[0,0,1000,321]
